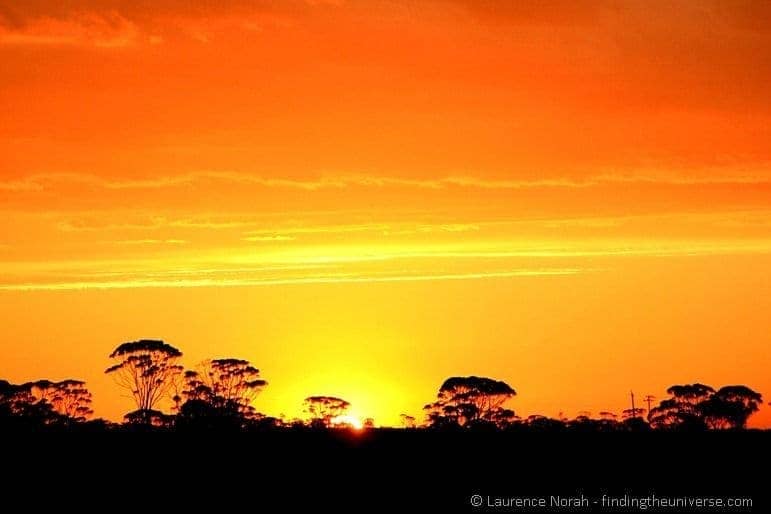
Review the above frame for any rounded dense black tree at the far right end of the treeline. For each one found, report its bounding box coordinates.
[699,385,763,430]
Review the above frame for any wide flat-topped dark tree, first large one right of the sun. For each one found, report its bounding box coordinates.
[423,376,517,428]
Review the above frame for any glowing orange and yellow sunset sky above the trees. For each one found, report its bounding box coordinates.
[0,0,771,427]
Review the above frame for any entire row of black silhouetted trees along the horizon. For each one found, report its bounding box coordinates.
[0,340,763,432]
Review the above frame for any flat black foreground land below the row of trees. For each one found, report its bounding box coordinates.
[0,429,771,512]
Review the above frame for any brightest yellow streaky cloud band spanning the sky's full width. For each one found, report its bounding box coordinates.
[0,240,771,291]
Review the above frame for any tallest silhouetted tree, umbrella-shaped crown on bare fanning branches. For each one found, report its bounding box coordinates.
[105,339,182,424]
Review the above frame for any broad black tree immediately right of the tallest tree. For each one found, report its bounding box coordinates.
[179,359,267,428]
